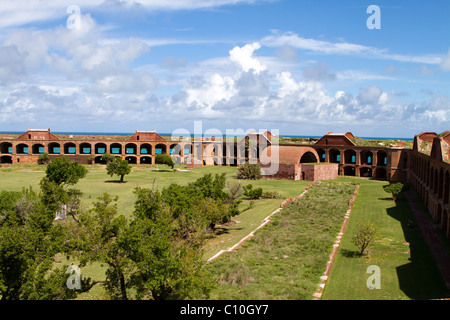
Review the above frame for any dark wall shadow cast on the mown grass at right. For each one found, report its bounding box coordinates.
[387,195,448,300]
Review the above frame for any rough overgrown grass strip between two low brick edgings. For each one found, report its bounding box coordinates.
[207,181,356,300]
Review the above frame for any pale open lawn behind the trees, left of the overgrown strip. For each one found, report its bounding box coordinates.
[0,165,308,299]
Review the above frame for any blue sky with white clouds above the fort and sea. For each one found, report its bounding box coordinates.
[0,0,450,138]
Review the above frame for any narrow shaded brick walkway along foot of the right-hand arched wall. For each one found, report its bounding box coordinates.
[405,191,450,290]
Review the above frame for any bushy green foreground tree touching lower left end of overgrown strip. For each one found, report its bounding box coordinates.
[123,188,214,300]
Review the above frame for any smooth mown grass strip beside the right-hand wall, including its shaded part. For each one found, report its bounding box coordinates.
[322,178,448,300]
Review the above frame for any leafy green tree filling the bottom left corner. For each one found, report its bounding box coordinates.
[0,188,90,300]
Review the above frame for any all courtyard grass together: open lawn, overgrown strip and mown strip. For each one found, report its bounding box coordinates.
[0,165,446,300]
